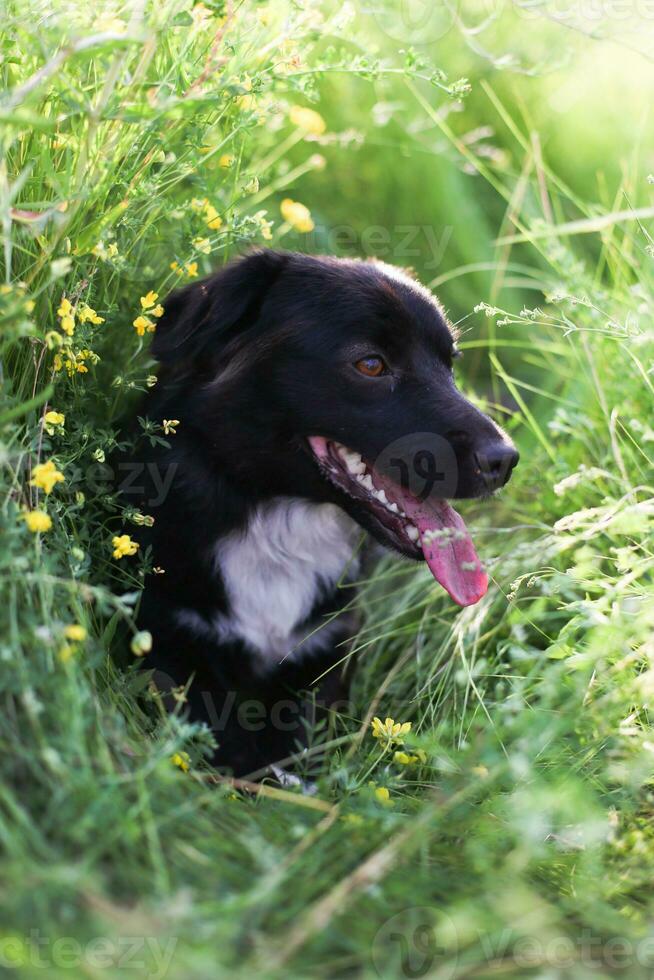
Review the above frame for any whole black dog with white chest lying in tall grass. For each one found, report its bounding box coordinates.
[126,251,518,774]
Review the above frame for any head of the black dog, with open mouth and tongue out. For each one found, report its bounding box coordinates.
[152,251,518,605]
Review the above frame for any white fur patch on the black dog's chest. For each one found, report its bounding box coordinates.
[180,497,361,669]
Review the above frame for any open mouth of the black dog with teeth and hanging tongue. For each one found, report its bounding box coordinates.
[308,436,488,606]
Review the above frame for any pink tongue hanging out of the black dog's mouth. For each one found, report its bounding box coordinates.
[395,490,488,606]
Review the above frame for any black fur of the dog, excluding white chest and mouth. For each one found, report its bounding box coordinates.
[118,251,517,774]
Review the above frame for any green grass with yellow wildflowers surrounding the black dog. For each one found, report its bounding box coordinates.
[0,0,654,980]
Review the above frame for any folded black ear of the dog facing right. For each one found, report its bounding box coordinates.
[151,249,288,364]
